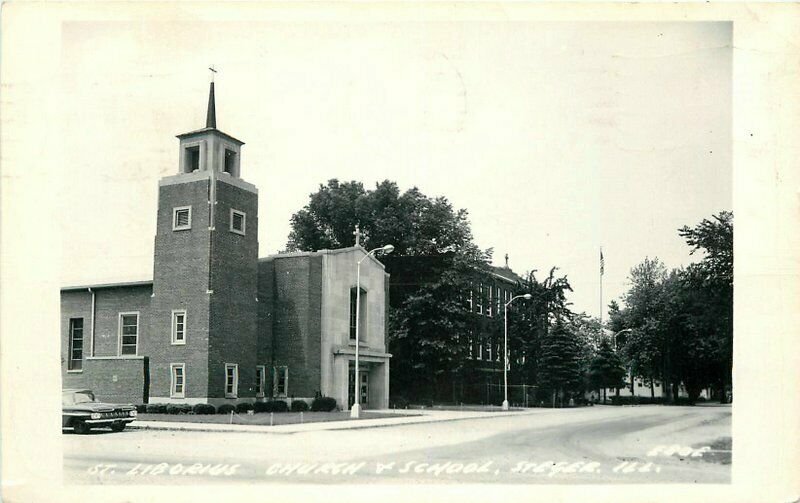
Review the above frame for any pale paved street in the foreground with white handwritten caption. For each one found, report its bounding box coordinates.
[63,406,731,484]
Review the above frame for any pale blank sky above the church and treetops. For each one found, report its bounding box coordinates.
[56,20,732,316]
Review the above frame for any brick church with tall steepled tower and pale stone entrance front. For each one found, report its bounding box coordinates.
[61,82,391,409]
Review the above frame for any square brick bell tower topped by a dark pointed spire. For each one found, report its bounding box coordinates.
[148,76,258,404]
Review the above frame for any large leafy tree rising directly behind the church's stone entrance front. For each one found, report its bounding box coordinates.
[287,179,491,399]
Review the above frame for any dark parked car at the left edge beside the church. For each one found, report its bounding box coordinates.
[61,389,136,435]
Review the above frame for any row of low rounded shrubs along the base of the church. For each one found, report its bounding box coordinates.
[136,396,336,414]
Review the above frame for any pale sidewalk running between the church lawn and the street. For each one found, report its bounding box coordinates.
[128,409,548,433]
